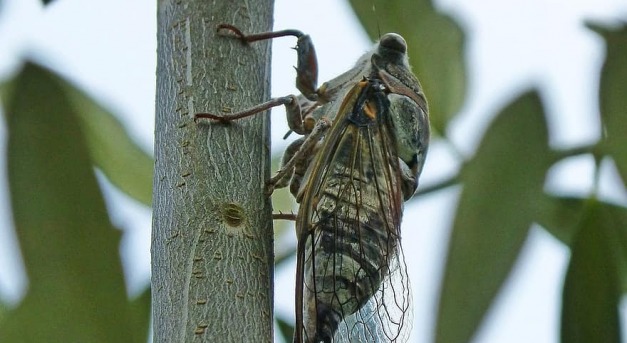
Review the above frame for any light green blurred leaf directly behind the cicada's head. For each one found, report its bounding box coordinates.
[350,0,466,133]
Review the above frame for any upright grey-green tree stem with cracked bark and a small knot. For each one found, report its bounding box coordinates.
[151,0,273,342]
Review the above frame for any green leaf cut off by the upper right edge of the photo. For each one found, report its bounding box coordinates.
[595,26,627,182]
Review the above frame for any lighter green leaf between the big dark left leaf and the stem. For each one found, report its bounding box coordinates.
[60,80,154,206]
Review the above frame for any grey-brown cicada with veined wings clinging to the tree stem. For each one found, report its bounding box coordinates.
[196,25,429,343]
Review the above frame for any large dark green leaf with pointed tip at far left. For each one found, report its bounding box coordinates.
[0,63,136,342]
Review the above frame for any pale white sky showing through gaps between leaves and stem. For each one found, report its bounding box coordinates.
[0,0,627,343]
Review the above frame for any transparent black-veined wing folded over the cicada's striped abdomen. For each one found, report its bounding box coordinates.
[295,81,410,342]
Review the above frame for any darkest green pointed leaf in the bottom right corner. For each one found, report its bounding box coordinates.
[561,203,621,343]
